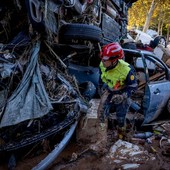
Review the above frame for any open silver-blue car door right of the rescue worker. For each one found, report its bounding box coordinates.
[143,51,170,124]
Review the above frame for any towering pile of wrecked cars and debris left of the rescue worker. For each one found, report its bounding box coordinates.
[0,0,135,166]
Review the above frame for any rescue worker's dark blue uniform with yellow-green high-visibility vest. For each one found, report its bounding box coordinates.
[99,59,137,127]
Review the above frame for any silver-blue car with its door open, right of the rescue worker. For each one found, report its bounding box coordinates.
[124,49,170,125]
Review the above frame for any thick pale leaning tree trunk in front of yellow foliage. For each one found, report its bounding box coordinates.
[143,0,156,32]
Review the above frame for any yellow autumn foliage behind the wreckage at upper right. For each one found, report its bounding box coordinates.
[128,0,170,34]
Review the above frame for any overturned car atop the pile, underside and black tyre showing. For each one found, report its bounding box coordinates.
[26,0,136,44]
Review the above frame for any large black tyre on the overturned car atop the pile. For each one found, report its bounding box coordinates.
[58,24,102,44]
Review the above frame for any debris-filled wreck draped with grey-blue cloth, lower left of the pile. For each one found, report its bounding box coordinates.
[0,36,88,163]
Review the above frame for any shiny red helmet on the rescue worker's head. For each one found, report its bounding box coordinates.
[101,42,124,62]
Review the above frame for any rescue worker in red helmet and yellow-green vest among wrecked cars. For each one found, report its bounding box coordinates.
[99,42,137,137]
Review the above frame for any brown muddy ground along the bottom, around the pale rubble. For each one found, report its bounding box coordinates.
[0,117,170,170]
